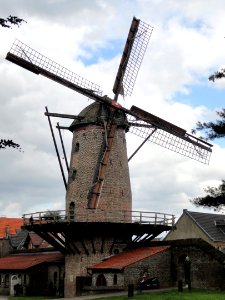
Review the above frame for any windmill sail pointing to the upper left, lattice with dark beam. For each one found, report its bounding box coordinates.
[6,40,102,95]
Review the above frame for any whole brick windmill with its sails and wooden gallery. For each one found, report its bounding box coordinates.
[6,18,211,297]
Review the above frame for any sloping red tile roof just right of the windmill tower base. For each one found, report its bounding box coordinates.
[90,246,170,270]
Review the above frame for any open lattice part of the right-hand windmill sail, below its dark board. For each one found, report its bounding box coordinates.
[127,115,212,164]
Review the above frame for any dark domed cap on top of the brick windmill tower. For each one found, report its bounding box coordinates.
[69,102,128,132]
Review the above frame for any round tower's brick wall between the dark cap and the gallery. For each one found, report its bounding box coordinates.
[66,125,132,222]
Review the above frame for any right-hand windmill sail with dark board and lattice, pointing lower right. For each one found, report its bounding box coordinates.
[127,106,212,164]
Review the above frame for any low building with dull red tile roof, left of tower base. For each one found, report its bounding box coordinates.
[0,252,65,296]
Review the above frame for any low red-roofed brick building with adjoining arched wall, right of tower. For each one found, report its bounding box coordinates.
[88,239,225,292]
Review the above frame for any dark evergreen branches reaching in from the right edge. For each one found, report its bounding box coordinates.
[191,69,225,211]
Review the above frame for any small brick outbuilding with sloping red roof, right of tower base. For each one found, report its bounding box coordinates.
[89,246,171,291]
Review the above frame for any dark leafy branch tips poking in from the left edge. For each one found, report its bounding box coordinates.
[0,15,26,151]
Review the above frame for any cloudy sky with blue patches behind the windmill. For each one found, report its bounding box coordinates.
[0,0,225,217]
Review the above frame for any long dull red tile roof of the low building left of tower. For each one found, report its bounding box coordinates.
[0,252,64,270]
